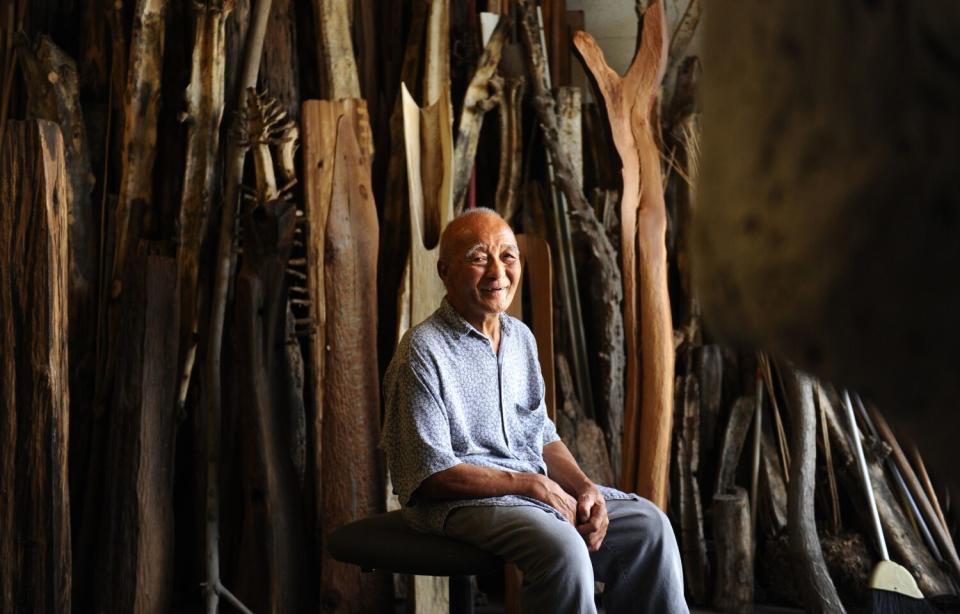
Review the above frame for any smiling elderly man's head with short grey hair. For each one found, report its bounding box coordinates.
[438,215,520,323]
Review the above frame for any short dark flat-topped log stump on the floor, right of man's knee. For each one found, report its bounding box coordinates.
[713,486,754,613]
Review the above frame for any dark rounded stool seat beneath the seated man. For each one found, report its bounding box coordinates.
[327,511,503,614]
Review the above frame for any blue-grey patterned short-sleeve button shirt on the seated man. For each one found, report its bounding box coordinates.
[381,299,636,534]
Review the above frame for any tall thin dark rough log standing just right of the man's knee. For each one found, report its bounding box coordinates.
[676,375,720,604]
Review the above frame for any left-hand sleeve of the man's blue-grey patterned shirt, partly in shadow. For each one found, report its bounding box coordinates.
[381,344,461,505]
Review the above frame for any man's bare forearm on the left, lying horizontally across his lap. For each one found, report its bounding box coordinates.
[417,466,577,524]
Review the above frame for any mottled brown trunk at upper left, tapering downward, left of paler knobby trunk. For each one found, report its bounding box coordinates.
[110,0,167,290]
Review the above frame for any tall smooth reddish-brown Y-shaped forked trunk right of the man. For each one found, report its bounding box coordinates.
[574,2,674,509]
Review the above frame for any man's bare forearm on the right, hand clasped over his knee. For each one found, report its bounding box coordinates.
[543,440,610,551]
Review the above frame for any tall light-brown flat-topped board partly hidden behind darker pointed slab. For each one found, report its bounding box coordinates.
[301,98,373,564]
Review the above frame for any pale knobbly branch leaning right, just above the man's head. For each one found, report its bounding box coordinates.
[453,17,511,213]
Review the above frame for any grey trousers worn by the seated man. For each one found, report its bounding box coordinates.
[444,499,689,614]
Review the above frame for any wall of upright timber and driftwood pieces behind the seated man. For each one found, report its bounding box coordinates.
[0,0,960,612]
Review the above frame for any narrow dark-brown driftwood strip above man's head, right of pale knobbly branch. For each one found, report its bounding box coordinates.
[494,78,524,223]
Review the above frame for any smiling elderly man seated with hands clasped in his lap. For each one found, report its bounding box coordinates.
[383,209,688,614]
